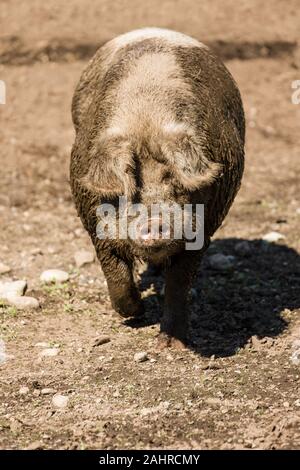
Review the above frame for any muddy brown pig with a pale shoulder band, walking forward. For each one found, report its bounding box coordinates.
[70,28,245,348]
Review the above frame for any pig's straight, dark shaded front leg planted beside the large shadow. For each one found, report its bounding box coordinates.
[158,251,202,349]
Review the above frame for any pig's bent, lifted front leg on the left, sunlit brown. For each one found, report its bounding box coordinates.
[96,246,143,317]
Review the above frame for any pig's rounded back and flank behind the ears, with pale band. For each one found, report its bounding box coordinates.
[72,28,245,234]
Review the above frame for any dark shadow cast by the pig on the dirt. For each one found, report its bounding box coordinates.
[126,238,300,357]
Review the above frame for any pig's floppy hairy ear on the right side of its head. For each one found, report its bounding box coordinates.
[164,130,223,191]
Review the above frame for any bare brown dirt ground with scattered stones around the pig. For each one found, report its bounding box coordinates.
[0,0,300,449]
